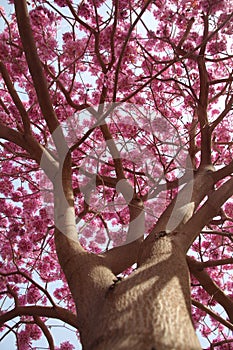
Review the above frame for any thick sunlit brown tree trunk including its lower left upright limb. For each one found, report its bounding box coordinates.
[55,157,201,350]
